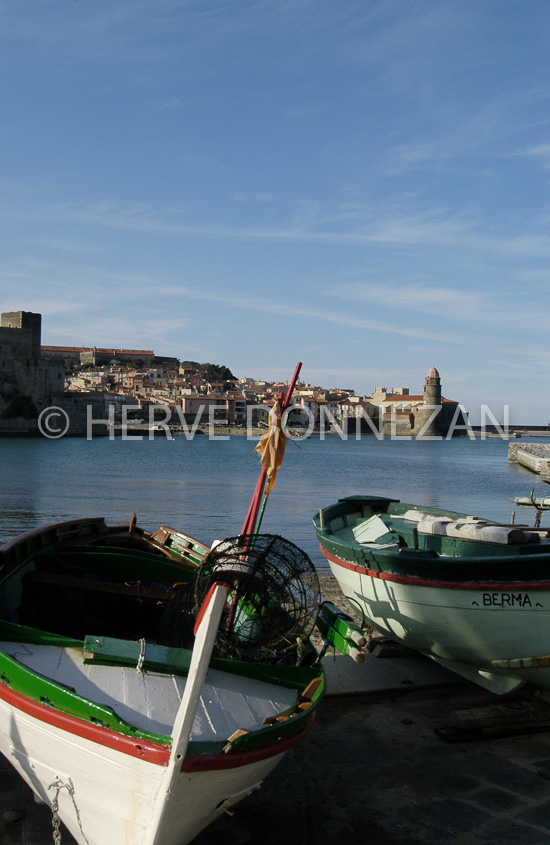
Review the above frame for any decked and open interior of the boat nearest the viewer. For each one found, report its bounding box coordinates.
[0,526,322,750]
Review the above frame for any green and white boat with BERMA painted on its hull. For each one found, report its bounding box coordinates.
[313,495,550,698]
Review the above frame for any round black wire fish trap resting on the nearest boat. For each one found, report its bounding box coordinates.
[160,534,321,663]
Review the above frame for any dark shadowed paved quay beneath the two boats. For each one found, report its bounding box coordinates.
[0,584,550,845]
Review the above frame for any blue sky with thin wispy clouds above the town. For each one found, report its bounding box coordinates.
[0,0,550,423]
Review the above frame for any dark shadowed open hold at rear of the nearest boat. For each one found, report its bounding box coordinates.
[0,532,197,645]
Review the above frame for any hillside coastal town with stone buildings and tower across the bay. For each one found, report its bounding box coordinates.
[0,311,467,436]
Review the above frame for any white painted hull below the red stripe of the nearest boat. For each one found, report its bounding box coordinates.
[0,680,284,845]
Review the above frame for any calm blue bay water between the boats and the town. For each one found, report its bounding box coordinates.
[0,436,548,569]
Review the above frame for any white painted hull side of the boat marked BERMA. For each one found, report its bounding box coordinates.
[329,561,550,693]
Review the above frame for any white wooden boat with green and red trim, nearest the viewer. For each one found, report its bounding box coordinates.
[0,519,324,845]
